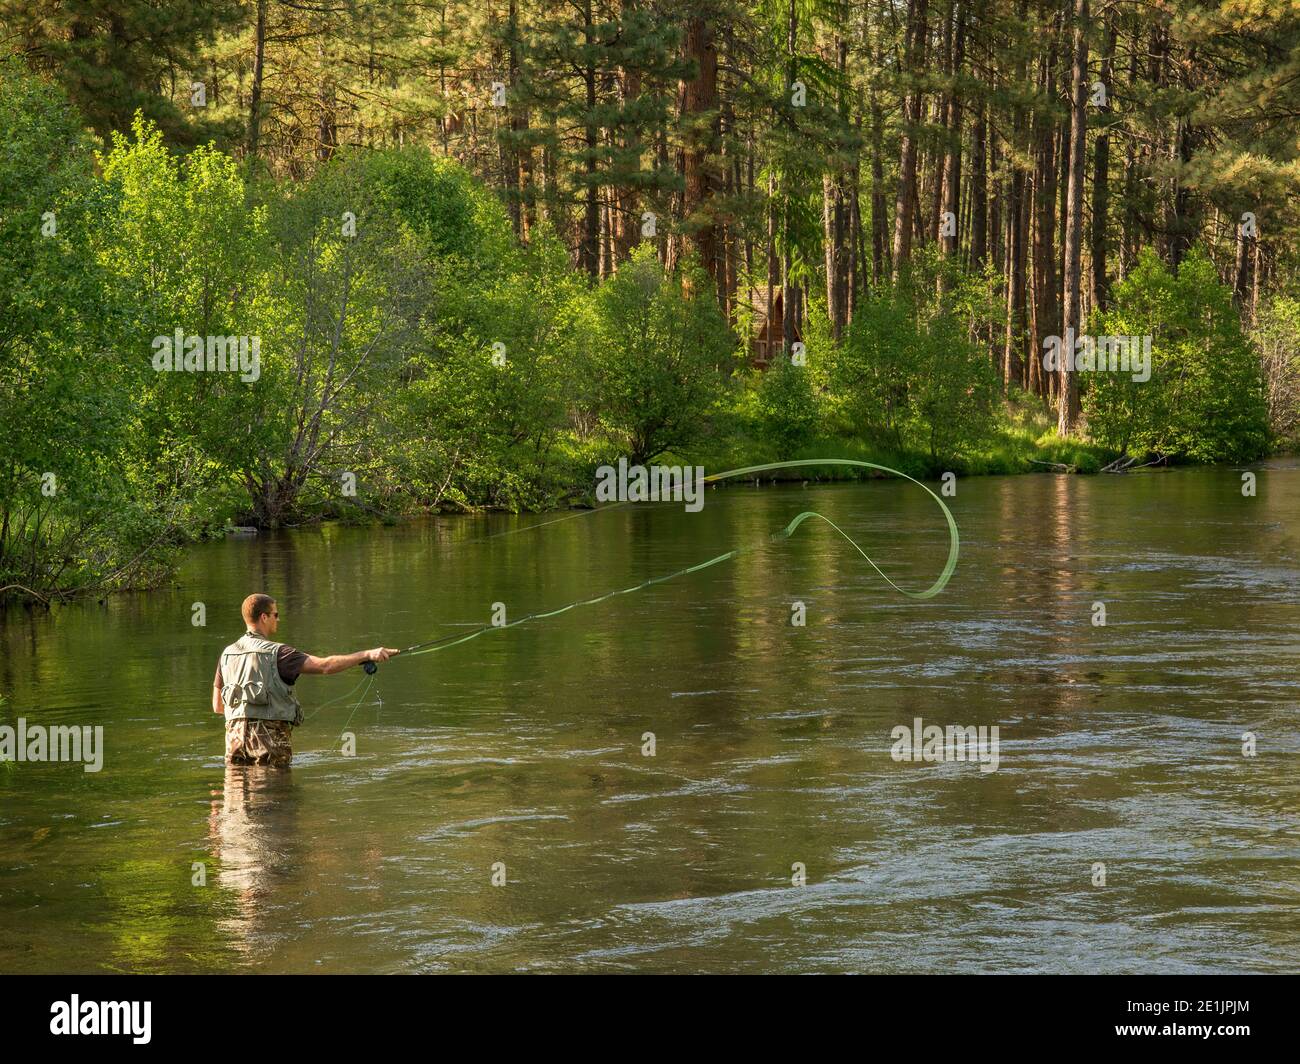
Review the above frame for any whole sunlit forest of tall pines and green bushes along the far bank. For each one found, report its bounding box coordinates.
[0,0,1300,602]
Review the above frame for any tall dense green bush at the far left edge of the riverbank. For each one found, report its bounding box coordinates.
[0,64,185,597]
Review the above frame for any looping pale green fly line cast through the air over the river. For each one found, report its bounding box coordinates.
[351,458,961,676]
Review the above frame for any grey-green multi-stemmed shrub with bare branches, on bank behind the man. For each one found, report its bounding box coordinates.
[239,153,433,525]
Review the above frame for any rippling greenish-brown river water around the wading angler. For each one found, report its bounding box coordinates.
[0,460,1300,973]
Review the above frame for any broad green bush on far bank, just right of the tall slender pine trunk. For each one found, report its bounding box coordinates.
[1083,248,1269,462]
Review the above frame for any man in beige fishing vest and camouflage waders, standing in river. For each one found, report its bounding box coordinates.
[212,594,398,765]
